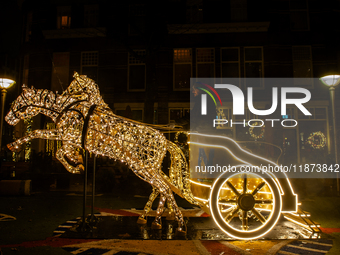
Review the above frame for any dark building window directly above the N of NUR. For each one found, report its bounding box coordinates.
[221,48,240,78]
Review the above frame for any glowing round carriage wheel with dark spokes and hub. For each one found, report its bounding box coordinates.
[209,168,282,239]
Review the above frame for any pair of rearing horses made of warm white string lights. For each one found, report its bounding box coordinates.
[5,73,198,232]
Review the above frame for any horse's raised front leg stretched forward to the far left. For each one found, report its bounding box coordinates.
[7,129,62,151]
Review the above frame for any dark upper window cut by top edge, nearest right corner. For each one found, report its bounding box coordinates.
[289,0,309,31]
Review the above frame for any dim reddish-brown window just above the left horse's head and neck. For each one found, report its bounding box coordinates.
[51,52,70,91]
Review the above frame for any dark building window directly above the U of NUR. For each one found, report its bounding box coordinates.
[244,47,264,88]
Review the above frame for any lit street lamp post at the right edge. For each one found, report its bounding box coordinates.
[320,74,340,195]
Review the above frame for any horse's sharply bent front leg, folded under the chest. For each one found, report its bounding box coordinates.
[56,144,84,173]
